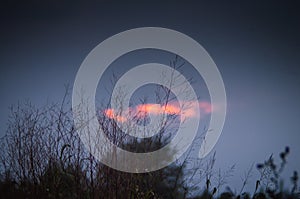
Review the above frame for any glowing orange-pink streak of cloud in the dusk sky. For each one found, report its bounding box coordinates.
[104,101,213,122]
